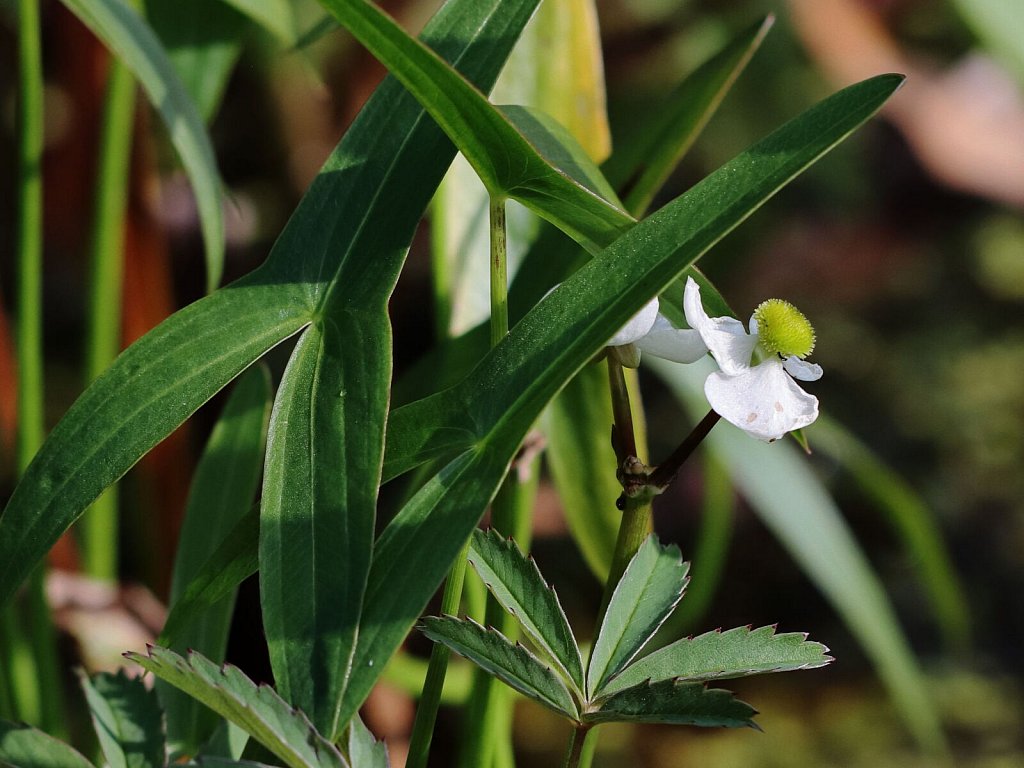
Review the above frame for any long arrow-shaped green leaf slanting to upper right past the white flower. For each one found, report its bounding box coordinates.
[342,76,902,719]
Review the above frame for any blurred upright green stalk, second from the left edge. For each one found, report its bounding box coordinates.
[79,37,135,581]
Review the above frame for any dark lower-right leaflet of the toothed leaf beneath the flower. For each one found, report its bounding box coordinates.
[585,680,760,730]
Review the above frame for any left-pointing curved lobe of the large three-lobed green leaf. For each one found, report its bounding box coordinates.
[0,280,309,603]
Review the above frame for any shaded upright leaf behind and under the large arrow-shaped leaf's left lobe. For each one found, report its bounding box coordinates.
[160,366,270,755]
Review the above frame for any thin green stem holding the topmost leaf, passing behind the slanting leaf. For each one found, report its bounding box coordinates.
[406,198,509,768]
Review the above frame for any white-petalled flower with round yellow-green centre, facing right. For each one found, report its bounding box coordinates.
[683,278,821,442]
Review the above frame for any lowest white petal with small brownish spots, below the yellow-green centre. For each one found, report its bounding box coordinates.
[705,358,818,440]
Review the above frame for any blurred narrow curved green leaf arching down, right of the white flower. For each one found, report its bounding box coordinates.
[813,415,971,650]
